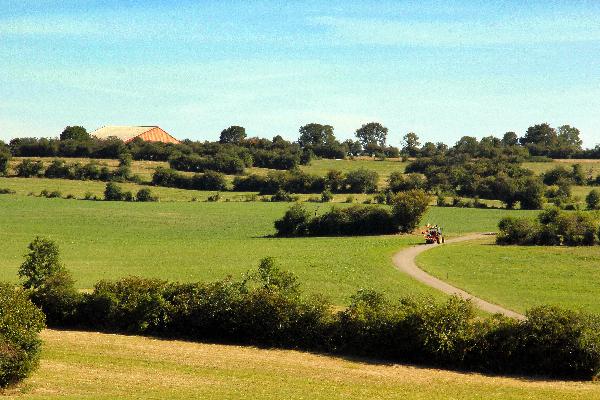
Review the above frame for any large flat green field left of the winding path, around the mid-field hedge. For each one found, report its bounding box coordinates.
[0,193,536,304]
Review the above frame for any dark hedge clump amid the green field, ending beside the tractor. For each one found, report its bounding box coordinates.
[275,190,430,236]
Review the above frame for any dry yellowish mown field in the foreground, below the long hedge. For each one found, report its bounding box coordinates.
[3,330,600,400]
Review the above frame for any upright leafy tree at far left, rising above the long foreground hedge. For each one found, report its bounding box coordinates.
[19,236,64,289]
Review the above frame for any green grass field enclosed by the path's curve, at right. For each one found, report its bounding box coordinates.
[417,239,600,313]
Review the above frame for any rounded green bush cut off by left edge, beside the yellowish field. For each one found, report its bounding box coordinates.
[0,283,44,387]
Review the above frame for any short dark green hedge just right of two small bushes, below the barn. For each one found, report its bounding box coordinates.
[152,167,227,190]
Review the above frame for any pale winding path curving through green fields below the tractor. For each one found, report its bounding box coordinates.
[392,233,525,319]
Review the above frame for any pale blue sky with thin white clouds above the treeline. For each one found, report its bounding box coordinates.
[0,0,600,147]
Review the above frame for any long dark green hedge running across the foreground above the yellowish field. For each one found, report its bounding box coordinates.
[31,259,600,379]
